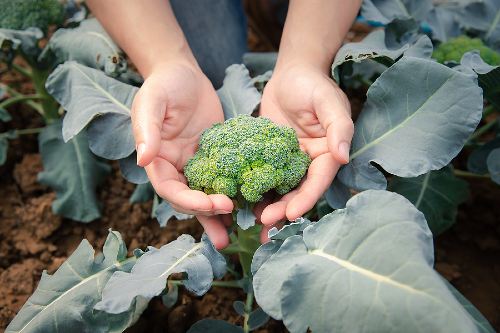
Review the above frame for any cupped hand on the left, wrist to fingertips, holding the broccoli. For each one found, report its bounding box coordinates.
[132,62,233,249]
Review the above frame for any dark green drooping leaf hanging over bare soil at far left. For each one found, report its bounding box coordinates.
[38,122,111,222]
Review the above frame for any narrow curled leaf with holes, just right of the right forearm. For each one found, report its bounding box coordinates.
[332,30,432,82]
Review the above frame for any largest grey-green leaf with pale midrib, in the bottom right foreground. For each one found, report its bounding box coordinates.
[253,190,484,333]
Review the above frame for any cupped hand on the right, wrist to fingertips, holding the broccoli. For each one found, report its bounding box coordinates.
[256,64,354,241]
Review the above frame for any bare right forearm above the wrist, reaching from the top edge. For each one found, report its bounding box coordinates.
[276,0,361,72]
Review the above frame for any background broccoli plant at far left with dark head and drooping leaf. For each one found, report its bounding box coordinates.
[0,4,137,222]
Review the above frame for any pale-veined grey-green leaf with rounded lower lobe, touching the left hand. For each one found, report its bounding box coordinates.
[46,61,138,159]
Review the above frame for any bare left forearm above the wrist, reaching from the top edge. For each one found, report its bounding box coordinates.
[86,0,197,77]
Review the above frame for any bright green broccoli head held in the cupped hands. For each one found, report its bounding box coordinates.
[184,115,311,202]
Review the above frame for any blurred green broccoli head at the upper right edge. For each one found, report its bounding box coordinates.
[432,36,500,66]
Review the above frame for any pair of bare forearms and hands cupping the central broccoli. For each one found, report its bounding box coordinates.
[87,0,361,248]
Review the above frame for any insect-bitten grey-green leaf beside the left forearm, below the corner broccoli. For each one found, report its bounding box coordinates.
[40,18,127,76]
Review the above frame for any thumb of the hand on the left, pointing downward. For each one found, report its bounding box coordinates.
[131,80,167,167]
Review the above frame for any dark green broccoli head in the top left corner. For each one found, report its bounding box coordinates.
[0,0,64,32]
